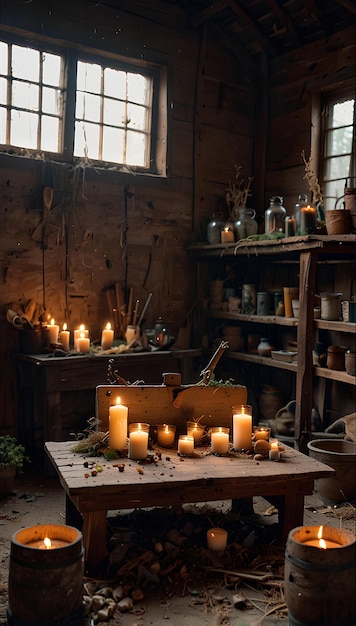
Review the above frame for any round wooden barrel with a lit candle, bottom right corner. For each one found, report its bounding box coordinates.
[284,526,356,626]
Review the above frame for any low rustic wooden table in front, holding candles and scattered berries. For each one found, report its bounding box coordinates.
[45,442,334,571]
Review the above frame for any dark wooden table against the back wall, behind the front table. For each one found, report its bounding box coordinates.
[14,349,201,453]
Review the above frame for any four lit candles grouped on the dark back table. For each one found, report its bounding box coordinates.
[47,319,114,354]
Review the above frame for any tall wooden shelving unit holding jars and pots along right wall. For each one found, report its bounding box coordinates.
[189,235,356,451]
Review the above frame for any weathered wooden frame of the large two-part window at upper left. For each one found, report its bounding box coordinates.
[0,28,170,178]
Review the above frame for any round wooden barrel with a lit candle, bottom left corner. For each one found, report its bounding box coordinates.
[8,524,84,626]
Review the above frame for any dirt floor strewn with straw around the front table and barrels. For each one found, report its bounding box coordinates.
[0,471,355,626]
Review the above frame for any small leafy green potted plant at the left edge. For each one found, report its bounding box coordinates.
[0,435,30,495]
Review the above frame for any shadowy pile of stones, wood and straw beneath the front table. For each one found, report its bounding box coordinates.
[83,505,286,624]
